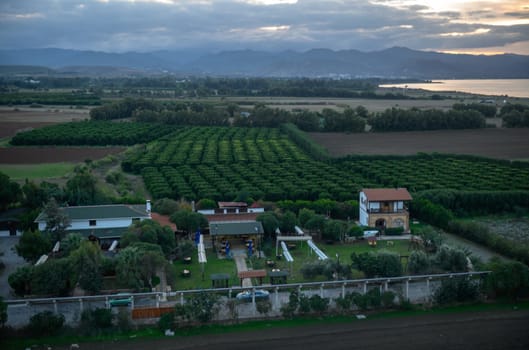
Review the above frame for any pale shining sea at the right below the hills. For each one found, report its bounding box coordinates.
[380,79,529,97]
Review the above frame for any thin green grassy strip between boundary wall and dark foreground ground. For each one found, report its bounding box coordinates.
[2,301,529,349]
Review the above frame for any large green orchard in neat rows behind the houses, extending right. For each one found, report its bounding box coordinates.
[115,127,529,201]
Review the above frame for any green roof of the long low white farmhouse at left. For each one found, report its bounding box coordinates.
[35,204,149,222]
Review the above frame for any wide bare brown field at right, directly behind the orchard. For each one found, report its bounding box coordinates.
[309,128,529,160]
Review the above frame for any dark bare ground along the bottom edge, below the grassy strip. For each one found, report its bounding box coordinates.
[49,311,529,350]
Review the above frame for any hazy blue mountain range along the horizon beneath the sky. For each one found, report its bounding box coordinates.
[0,47,529,79]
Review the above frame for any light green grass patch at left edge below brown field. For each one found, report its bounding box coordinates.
[0,163,75,181]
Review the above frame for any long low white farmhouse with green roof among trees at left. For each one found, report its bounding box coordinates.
[35,201,151,240]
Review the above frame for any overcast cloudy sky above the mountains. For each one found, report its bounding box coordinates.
[0,0,529,55]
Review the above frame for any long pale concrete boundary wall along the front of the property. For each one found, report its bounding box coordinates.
[6,271,490,328]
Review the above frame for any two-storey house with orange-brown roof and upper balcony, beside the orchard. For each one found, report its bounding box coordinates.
[359,188,412,232]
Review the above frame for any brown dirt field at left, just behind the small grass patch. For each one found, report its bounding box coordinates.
[0,147,125,164]
